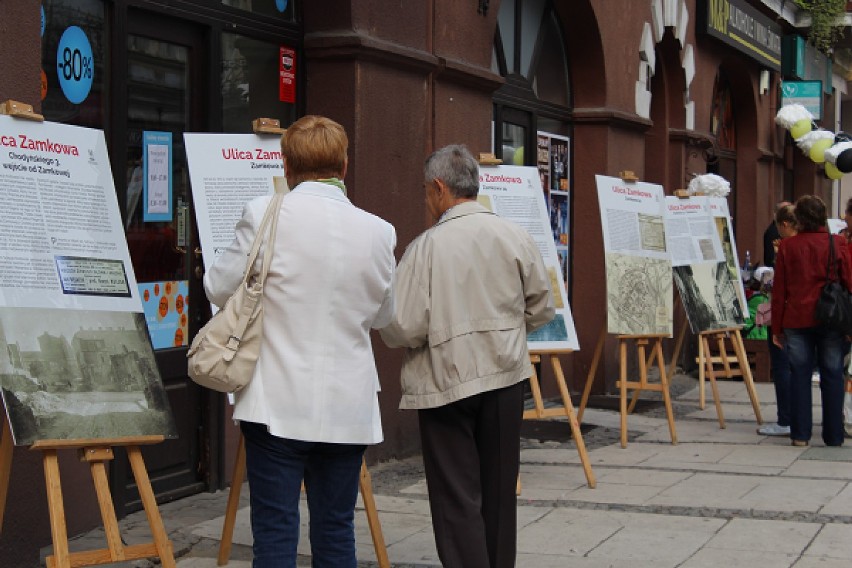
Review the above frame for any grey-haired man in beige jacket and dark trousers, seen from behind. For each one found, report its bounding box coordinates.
[381,145,554,568]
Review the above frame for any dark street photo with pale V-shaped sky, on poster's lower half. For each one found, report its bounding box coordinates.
[674,260,744,333]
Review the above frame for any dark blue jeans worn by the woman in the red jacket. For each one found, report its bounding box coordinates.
[784,326,846,446]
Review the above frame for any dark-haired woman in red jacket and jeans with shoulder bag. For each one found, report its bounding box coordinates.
[772,195,852,446]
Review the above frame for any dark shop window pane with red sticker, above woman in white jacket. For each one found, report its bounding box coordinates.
[222,33,300,132]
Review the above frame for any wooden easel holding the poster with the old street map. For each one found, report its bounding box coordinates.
[579,327,677,448]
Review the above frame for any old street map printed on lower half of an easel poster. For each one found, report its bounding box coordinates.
[606,252,672,335]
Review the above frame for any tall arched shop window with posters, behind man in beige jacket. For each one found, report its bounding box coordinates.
[492,0,572,282]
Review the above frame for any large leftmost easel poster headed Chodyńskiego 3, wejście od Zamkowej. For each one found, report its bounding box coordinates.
[0,116,176,445]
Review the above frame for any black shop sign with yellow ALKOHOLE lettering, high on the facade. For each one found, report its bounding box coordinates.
[698,0,781,71]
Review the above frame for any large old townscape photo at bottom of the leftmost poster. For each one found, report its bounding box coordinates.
[0,307,177,445]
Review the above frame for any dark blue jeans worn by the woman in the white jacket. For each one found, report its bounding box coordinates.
[240,422,367,568]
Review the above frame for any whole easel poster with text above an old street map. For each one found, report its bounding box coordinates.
[595,175,673,335]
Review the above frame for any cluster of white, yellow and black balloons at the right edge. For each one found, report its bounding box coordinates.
[775,104,852,179]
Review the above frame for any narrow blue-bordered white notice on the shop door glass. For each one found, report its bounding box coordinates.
[142,131,172,222]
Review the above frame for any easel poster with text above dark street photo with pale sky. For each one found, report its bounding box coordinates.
[665,197,743,333]
